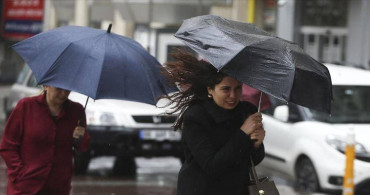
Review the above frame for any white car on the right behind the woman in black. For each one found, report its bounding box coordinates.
[261,64,370,195]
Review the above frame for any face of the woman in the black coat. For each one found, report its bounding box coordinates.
[208,76,242,110]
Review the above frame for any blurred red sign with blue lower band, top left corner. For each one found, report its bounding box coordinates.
[1,0,44,39]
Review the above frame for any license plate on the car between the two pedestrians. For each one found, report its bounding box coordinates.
[139,130,181,141]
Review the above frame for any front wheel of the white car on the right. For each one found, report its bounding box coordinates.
[295,157,320,193]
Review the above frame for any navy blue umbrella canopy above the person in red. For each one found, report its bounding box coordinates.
[13,26,175,104]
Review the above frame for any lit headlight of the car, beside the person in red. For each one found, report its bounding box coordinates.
[86,111,118,126]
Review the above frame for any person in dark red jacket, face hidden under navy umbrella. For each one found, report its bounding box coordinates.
[0,86,90,195]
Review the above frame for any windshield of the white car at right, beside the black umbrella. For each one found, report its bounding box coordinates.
[307,86,370,123]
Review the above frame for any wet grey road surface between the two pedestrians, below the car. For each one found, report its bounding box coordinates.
[0,157,181,195]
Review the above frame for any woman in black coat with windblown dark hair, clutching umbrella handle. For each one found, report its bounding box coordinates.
[163,51,265,195]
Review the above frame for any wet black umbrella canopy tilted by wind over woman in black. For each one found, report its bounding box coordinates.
[175,15,332,113]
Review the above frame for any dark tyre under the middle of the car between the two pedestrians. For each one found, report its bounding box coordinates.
[113,156,136,177]
